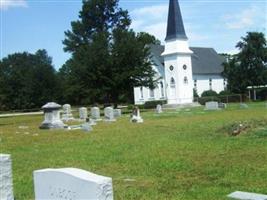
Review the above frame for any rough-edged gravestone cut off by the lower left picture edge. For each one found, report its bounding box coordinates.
[0,154,14,200]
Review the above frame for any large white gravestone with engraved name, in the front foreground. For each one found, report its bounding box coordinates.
[33,168,113,200]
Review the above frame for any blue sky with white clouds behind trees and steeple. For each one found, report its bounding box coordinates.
[0,0,267,69]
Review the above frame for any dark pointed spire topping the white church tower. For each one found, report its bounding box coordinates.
[165,0,187,41]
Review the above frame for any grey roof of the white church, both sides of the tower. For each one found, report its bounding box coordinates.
[150,45,225,74]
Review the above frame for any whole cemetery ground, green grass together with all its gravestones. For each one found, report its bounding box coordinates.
[0,102,267,200]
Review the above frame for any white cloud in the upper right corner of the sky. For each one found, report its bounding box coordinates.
[223,6,266,29]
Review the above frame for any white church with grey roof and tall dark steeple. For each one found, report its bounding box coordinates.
[134,0,227,105]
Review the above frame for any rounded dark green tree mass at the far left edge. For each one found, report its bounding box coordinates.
[0,50,57,110]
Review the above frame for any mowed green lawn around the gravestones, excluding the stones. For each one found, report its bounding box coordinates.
[0,103,267,200]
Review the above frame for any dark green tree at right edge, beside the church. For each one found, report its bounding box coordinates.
[223,32,267,93]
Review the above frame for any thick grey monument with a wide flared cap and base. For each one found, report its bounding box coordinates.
[40,102,67,129]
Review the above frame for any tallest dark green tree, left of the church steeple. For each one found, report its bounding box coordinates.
[60,0,155,104]
